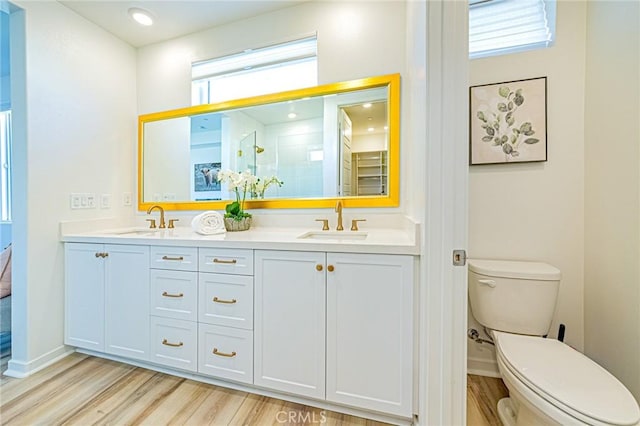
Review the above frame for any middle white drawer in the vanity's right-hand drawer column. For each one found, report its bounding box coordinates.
[198,272,253,330]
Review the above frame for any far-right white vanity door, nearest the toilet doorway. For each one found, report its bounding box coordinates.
[327,253,413,417]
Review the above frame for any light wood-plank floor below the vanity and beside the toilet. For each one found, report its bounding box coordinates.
[0,354,506,426]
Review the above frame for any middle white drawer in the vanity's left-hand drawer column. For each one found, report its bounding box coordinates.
[149,269,198,321]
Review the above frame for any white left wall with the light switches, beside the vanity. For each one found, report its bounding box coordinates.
[9,2,136,371]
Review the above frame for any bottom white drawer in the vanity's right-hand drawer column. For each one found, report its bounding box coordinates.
[198,324,253,383]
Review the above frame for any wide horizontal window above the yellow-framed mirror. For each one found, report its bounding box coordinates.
[191,36,318,105]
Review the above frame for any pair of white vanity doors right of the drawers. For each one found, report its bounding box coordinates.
[254,250,414,417]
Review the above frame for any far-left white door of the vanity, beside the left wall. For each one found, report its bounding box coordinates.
[64,243,104,352]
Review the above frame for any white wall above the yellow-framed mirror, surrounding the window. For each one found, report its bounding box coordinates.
[138,1,405,114]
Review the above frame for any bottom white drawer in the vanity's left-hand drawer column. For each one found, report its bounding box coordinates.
[150,317,198,371]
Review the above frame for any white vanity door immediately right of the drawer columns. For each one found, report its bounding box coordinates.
[254,250,325,398]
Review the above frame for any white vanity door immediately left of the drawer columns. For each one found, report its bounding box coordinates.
[104,245,149,360]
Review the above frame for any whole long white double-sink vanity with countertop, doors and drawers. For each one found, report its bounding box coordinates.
[63,224,419,423]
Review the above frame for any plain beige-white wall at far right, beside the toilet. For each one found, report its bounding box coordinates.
[584,1,640,401]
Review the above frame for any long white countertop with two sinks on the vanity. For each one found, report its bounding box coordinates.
[61,223,420,255]
